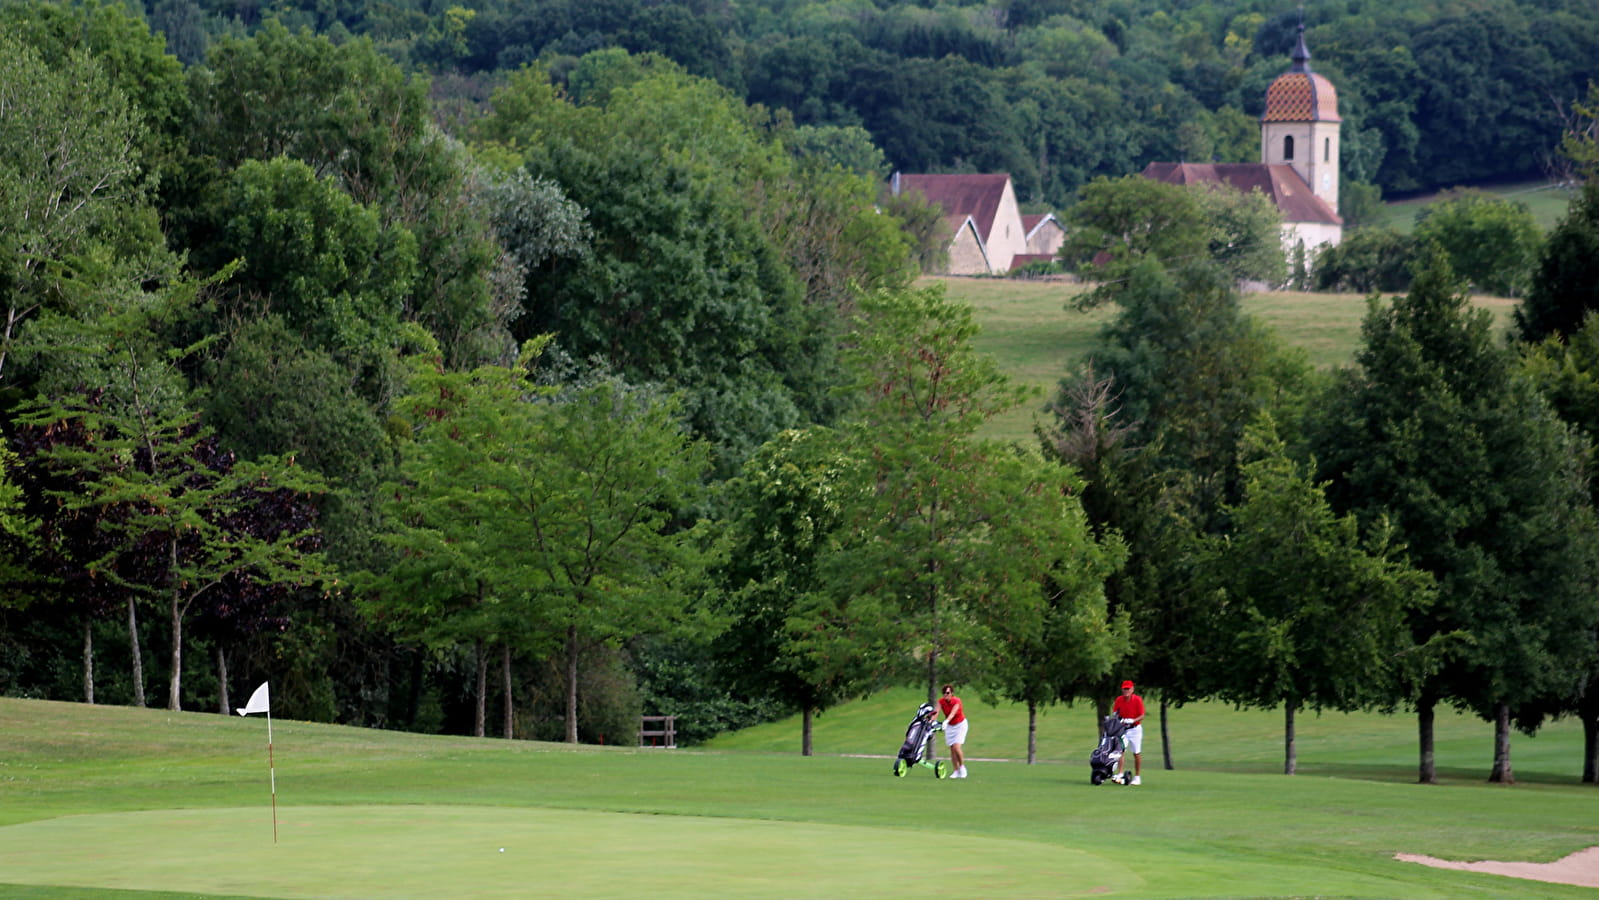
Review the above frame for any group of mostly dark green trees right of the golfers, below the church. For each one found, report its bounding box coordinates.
[1047,165,1599,782]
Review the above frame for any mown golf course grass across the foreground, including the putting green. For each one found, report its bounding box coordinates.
[0,691,1599,900]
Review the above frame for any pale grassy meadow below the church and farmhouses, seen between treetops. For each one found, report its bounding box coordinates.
[946,277,1517,443]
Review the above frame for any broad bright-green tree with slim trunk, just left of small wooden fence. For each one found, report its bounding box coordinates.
[379,344,705,742]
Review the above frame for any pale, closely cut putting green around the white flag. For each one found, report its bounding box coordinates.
[0,806,1142,900]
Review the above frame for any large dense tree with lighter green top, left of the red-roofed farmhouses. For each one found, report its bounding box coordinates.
[481,54,838,473]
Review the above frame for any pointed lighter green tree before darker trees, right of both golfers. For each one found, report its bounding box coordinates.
[1201,417,1433,775]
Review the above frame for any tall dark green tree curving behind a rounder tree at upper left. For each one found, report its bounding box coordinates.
[186,21,508,368]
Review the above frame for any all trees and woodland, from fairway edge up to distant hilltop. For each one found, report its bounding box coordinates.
[0,0,1599,780]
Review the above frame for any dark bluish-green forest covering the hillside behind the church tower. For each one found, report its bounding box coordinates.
[147,0,1599,209]
